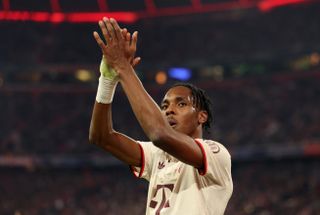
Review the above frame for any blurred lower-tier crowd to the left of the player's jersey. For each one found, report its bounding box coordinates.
[0,167,147,215]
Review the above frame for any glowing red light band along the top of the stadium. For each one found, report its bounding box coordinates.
[0,0,319,23]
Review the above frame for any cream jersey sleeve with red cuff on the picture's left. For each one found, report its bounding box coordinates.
[130,141,156,181]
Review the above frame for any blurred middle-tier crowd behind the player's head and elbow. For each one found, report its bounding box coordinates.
[0,73,320,155]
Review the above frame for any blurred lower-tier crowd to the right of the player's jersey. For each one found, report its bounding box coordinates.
[226,160,320,215]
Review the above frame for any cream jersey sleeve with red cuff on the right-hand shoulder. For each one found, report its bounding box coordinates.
[195,139,232,186]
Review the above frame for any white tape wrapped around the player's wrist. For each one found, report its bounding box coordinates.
[96,75,119,104]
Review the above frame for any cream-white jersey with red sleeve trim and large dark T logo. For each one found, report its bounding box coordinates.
[131,139,233,215]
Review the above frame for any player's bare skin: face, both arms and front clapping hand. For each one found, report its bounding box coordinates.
[89,19,207,168]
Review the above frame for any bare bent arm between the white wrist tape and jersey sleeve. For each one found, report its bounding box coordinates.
[89,101,141,167]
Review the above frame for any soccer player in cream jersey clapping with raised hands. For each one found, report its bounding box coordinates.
[89,17,233,215]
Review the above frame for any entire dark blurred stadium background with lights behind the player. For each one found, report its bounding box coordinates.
[0,0,320,215]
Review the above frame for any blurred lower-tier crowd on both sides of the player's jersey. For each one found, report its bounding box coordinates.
[0,160,320,215]
